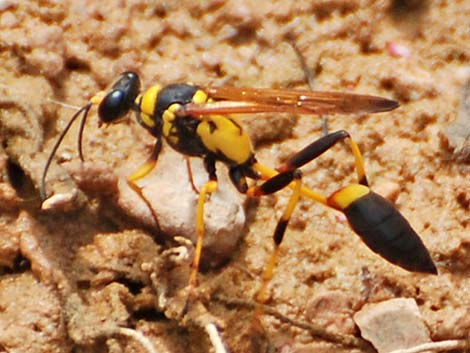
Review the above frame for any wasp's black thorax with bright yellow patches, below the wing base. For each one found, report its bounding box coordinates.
[136,84,254,166]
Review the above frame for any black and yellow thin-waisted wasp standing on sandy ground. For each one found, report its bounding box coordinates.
[40,72,437,301]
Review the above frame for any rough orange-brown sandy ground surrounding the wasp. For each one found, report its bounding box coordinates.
[0,0,470,353]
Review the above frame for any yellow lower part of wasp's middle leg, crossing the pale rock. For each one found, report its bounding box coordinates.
[189,180,217,287]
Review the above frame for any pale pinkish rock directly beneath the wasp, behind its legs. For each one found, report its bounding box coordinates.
[118,148,246,267]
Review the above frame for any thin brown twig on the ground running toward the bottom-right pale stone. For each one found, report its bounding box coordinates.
[214,295,371,348]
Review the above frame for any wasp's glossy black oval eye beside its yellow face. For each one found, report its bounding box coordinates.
[98,72,140,123]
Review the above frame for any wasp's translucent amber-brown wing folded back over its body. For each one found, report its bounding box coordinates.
[180,86,399,115]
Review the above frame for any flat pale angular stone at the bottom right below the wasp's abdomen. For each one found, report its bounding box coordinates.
[354,298,431,353]
